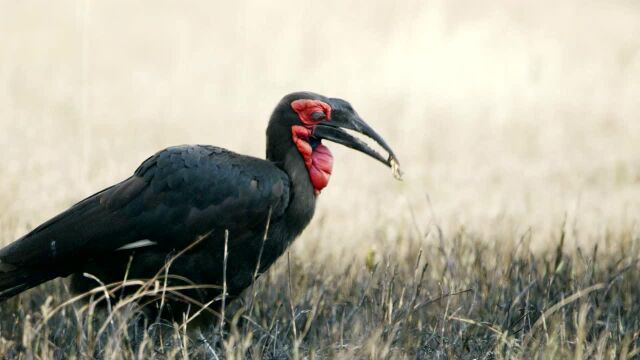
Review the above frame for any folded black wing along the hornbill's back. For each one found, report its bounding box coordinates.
[0,145,289,272]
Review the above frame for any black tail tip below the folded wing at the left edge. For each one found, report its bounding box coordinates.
[0,262,58,302]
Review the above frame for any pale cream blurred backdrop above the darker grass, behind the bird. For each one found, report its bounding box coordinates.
[0,0,640,252]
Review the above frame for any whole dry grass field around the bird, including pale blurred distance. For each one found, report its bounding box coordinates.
[0,0,640,359]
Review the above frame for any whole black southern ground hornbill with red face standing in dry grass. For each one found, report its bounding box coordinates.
[0,92,399,319]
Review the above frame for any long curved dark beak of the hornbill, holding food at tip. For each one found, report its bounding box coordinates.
[312,115,402,179]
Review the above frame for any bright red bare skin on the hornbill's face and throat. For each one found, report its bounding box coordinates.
[291,99,333,196]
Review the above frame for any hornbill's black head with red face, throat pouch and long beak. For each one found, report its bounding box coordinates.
[267,92,400,194]
